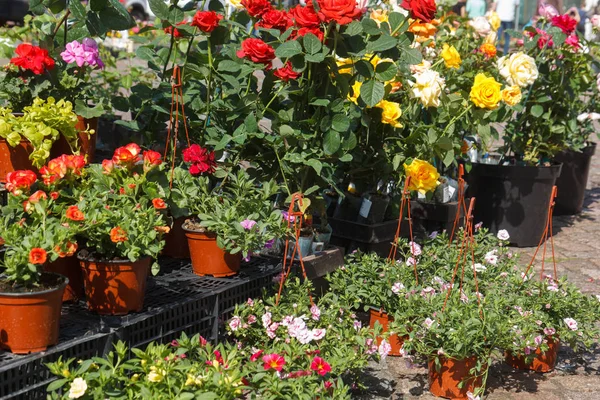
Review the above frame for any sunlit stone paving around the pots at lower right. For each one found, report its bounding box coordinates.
[359,149,600,400]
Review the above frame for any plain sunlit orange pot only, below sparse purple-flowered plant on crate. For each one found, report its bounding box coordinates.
[183,228,242,277]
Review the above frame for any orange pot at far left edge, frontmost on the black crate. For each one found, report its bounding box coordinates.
[0,274,68,354]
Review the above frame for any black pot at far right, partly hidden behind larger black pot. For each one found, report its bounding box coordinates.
[554,143,596,215]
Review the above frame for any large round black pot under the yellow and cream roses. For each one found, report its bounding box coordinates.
[467,163,562,247]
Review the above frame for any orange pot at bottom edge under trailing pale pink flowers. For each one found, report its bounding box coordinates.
[429,356,482,399]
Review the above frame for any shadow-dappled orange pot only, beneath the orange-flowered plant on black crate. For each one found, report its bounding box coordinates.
[79,256,152,315]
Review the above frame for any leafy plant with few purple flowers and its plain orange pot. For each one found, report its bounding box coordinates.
[183,170,284,277]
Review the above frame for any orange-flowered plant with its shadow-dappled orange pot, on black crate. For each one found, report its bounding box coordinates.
[70,143,169,314]
